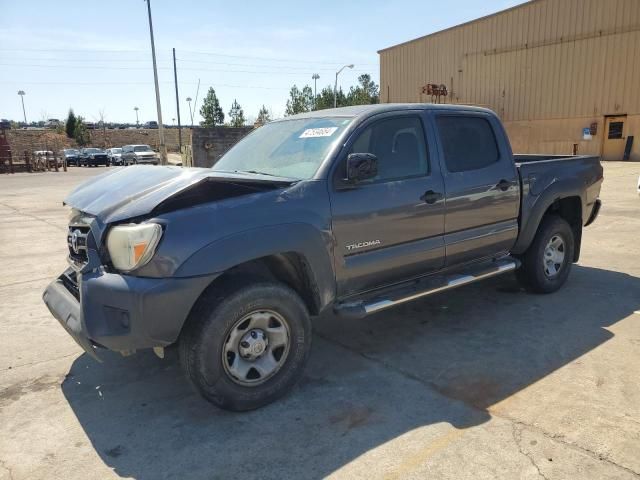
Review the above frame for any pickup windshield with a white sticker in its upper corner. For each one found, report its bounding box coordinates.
[211,117,352,180]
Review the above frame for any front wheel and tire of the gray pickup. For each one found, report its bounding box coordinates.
[179,280,311,411]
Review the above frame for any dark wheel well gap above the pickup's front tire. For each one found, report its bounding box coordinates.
[199,252,320,315]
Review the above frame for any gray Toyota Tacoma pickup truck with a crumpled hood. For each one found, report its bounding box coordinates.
[44,104,603,410]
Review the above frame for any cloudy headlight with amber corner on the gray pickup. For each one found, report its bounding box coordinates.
[107,223,162,272]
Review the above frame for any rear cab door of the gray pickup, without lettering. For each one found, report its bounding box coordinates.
[433,110,520,266]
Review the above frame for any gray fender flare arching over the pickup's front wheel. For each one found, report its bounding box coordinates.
[174,223,335,308]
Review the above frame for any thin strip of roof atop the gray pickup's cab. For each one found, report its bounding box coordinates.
[279,103,493,121]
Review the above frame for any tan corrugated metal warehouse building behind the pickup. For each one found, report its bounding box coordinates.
[378,0,640,161]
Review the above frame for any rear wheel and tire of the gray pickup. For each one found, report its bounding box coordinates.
[516,215,575,293]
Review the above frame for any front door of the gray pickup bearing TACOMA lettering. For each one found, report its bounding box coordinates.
[330,111,444,297]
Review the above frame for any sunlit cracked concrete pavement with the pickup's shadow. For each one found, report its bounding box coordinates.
[0,163,640,480]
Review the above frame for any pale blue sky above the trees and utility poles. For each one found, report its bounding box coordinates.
[0,0,523,124]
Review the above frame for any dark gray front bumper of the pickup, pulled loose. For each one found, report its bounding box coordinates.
[42,269,217,359]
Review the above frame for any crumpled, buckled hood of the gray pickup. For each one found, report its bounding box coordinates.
[64,165,292,223]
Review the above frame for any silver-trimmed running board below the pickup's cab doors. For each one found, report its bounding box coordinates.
[334,257,520,318]
